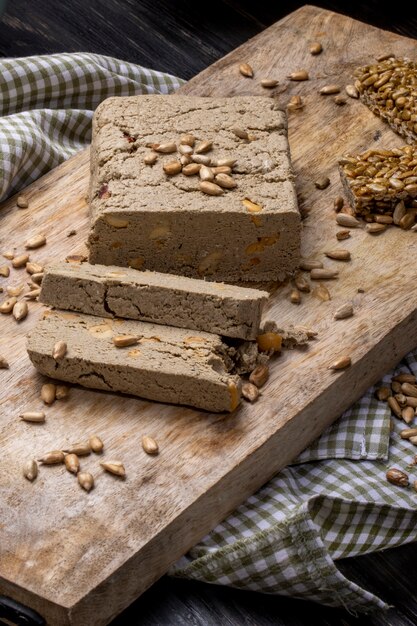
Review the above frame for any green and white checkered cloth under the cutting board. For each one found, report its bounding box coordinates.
[0,54,417,612]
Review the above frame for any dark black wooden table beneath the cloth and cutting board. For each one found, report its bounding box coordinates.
[0,0,417,626]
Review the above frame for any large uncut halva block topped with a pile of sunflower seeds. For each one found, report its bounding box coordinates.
[88,96,301,281]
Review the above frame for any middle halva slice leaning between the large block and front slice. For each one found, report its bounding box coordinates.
[39,262,269,339]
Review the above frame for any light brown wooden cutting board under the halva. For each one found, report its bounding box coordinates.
[0,6,417,626]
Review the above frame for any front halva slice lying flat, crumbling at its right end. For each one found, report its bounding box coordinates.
[27,311,241,412]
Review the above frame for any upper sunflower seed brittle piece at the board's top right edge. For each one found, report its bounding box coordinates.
[355,57,417,144]
